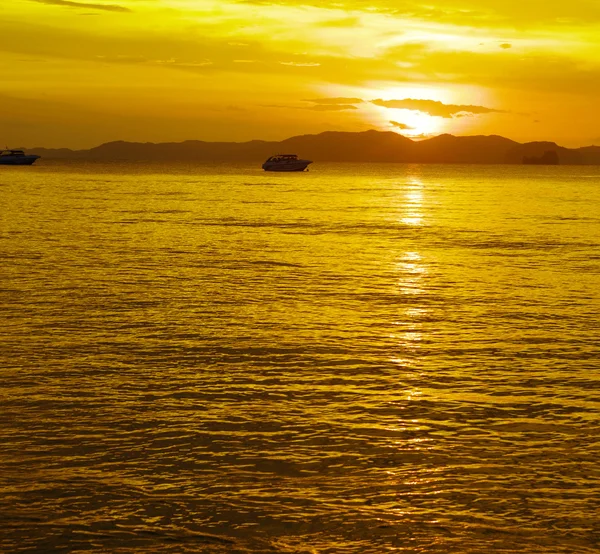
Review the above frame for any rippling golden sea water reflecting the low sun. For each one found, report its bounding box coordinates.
[0,160,600,554]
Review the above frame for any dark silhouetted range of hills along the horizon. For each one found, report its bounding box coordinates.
[28,131,600,165]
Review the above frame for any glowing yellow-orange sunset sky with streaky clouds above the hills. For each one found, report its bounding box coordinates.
[0,0,600,148]
